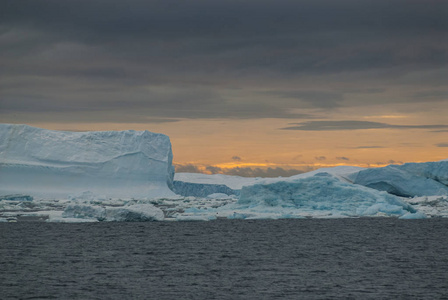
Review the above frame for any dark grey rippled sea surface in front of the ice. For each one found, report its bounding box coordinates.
[0,218,448,299]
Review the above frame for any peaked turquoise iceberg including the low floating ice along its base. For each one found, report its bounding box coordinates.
[186,173,416,219]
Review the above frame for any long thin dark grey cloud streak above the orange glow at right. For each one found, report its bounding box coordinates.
[281,120,448,131]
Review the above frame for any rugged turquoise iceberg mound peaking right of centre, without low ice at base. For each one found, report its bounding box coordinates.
[237,173,416,217]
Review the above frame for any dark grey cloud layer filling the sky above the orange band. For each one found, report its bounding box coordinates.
[0,0,448,122]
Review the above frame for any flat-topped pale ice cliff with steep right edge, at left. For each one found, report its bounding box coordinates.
[0,124,174,197]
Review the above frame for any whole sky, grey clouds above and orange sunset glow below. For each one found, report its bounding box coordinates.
[0,0,448,176]
